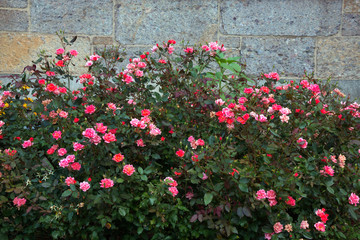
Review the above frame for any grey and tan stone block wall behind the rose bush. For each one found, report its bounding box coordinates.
[0,0,360,97]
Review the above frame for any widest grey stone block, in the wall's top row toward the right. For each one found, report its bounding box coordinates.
[220,0,342,36]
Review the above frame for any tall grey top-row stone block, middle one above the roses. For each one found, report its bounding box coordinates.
[115,0,218,45]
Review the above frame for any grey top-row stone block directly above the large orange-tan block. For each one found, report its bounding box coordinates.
[30,0,113,35]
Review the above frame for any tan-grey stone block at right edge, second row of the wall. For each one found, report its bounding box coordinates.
[316,37,360,80]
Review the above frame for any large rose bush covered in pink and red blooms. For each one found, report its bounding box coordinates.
[0,36,360,239]
